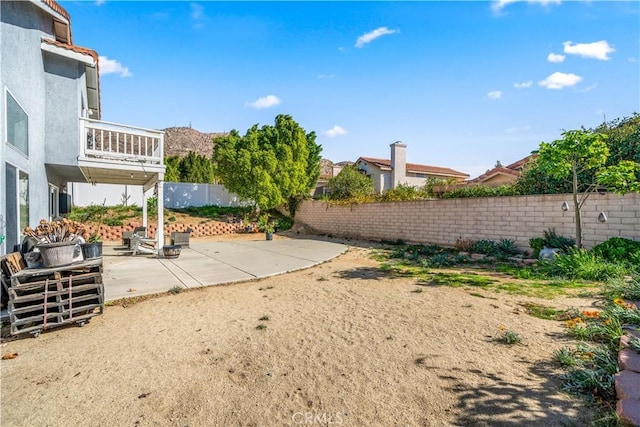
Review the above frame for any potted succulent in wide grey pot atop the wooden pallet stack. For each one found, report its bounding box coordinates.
[24,219,86,267]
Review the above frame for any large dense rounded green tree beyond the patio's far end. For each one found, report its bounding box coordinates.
[213,114,322,210]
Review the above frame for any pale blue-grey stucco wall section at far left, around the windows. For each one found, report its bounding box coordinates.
[0,1,53,252]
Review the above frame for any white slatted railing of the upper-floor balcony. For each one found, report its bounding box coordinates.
[80,118,164,165]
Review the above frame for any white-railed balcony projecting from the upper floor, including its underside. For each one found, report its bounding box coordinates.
[78,118,165,188]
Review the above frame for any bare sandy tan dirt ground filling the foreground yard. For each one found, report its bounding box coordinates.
[0,236,591,426]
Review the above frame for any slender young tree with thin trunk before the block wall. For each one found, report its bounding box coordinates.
[538,129,609,248]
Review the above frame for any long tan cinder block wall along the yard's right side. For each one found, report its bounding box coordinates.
[294,193,640,250]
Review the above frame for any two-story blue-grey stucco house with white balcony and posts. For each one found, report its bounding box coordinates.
[0,0,165,253]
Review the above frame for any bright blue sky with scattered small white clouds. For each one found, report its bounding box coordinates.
[61,0,640,177]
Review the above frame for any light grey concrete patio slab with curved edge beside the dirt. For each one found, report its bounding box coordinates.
[102,233,347,301]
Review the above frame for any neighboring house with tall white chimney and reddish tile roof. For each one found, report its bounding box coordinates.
[356,141,469,193]
